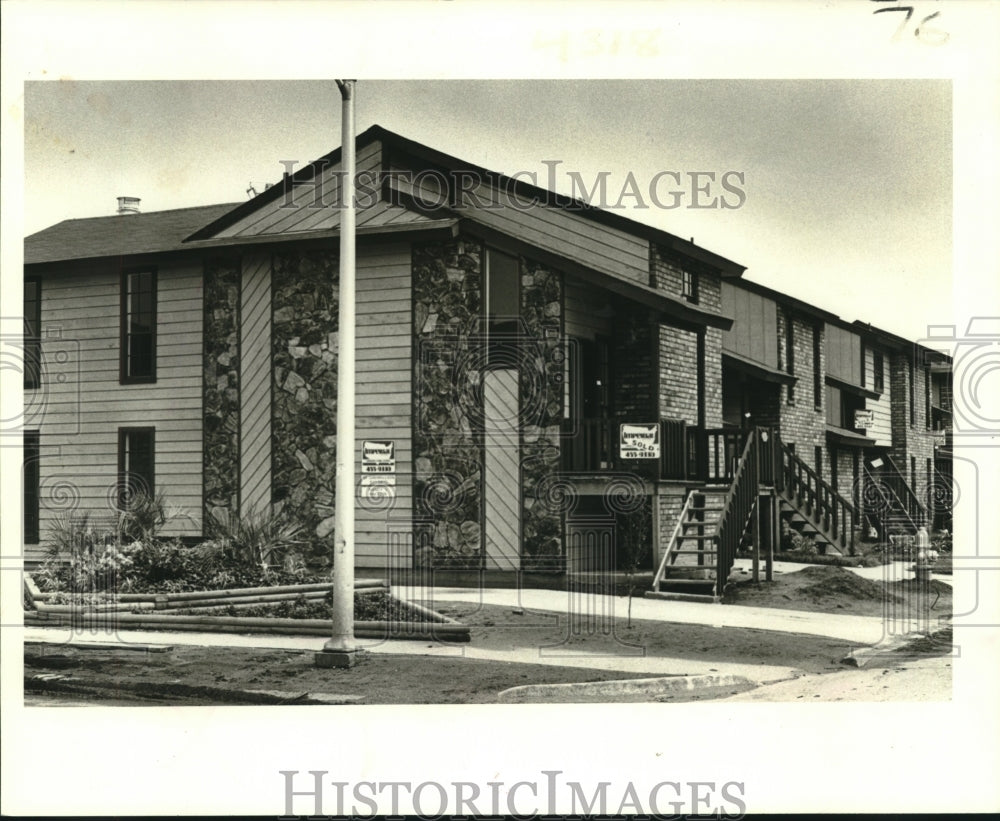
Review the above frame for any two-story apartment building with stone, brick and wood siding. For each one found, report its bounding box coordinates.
[24,126,944,587]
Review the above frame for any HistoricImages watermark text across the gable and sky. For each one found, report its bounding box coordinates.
[279,159,747,211]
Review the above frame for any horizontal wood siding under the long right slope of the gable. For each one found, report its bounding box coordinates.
[394,162,649,285]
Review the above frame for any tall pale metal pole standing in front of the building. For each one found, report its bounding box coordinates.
[315,80,358,667]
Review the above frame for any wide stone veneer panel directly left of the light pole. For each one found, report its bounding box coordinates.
[271,249,339,556]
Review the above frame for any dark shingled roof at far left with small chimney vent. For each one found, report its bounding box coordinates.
[24,203,239,265]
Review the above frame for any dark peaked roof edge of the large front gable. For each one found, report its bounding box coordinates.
[188,125,746,277]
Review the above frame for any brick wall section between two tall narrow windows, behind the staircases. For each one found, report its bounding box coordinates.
[778,311,830,481]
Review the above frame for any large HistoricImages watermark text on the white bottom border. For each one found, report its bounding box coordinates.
[278,770,747,819]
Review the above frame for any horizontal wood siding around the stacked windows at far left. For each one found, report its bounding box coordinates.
[25,262,202,558]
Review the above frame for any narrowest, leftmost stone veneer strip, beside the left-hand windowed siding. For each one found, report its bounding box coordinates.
[202,259,240,524]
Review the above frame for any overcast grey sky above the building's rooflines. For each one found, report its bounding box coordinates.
[19,80,952,338]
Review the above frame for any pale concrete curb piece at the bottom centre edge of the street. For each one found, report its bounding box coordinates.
[497,673,756,704]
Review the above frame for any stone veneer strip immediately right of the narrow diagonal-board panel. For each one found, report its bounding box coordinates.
[520,259,566,570]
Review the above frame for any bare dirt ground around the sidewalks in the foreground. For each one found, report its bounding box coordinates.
[24,567,951,705]
